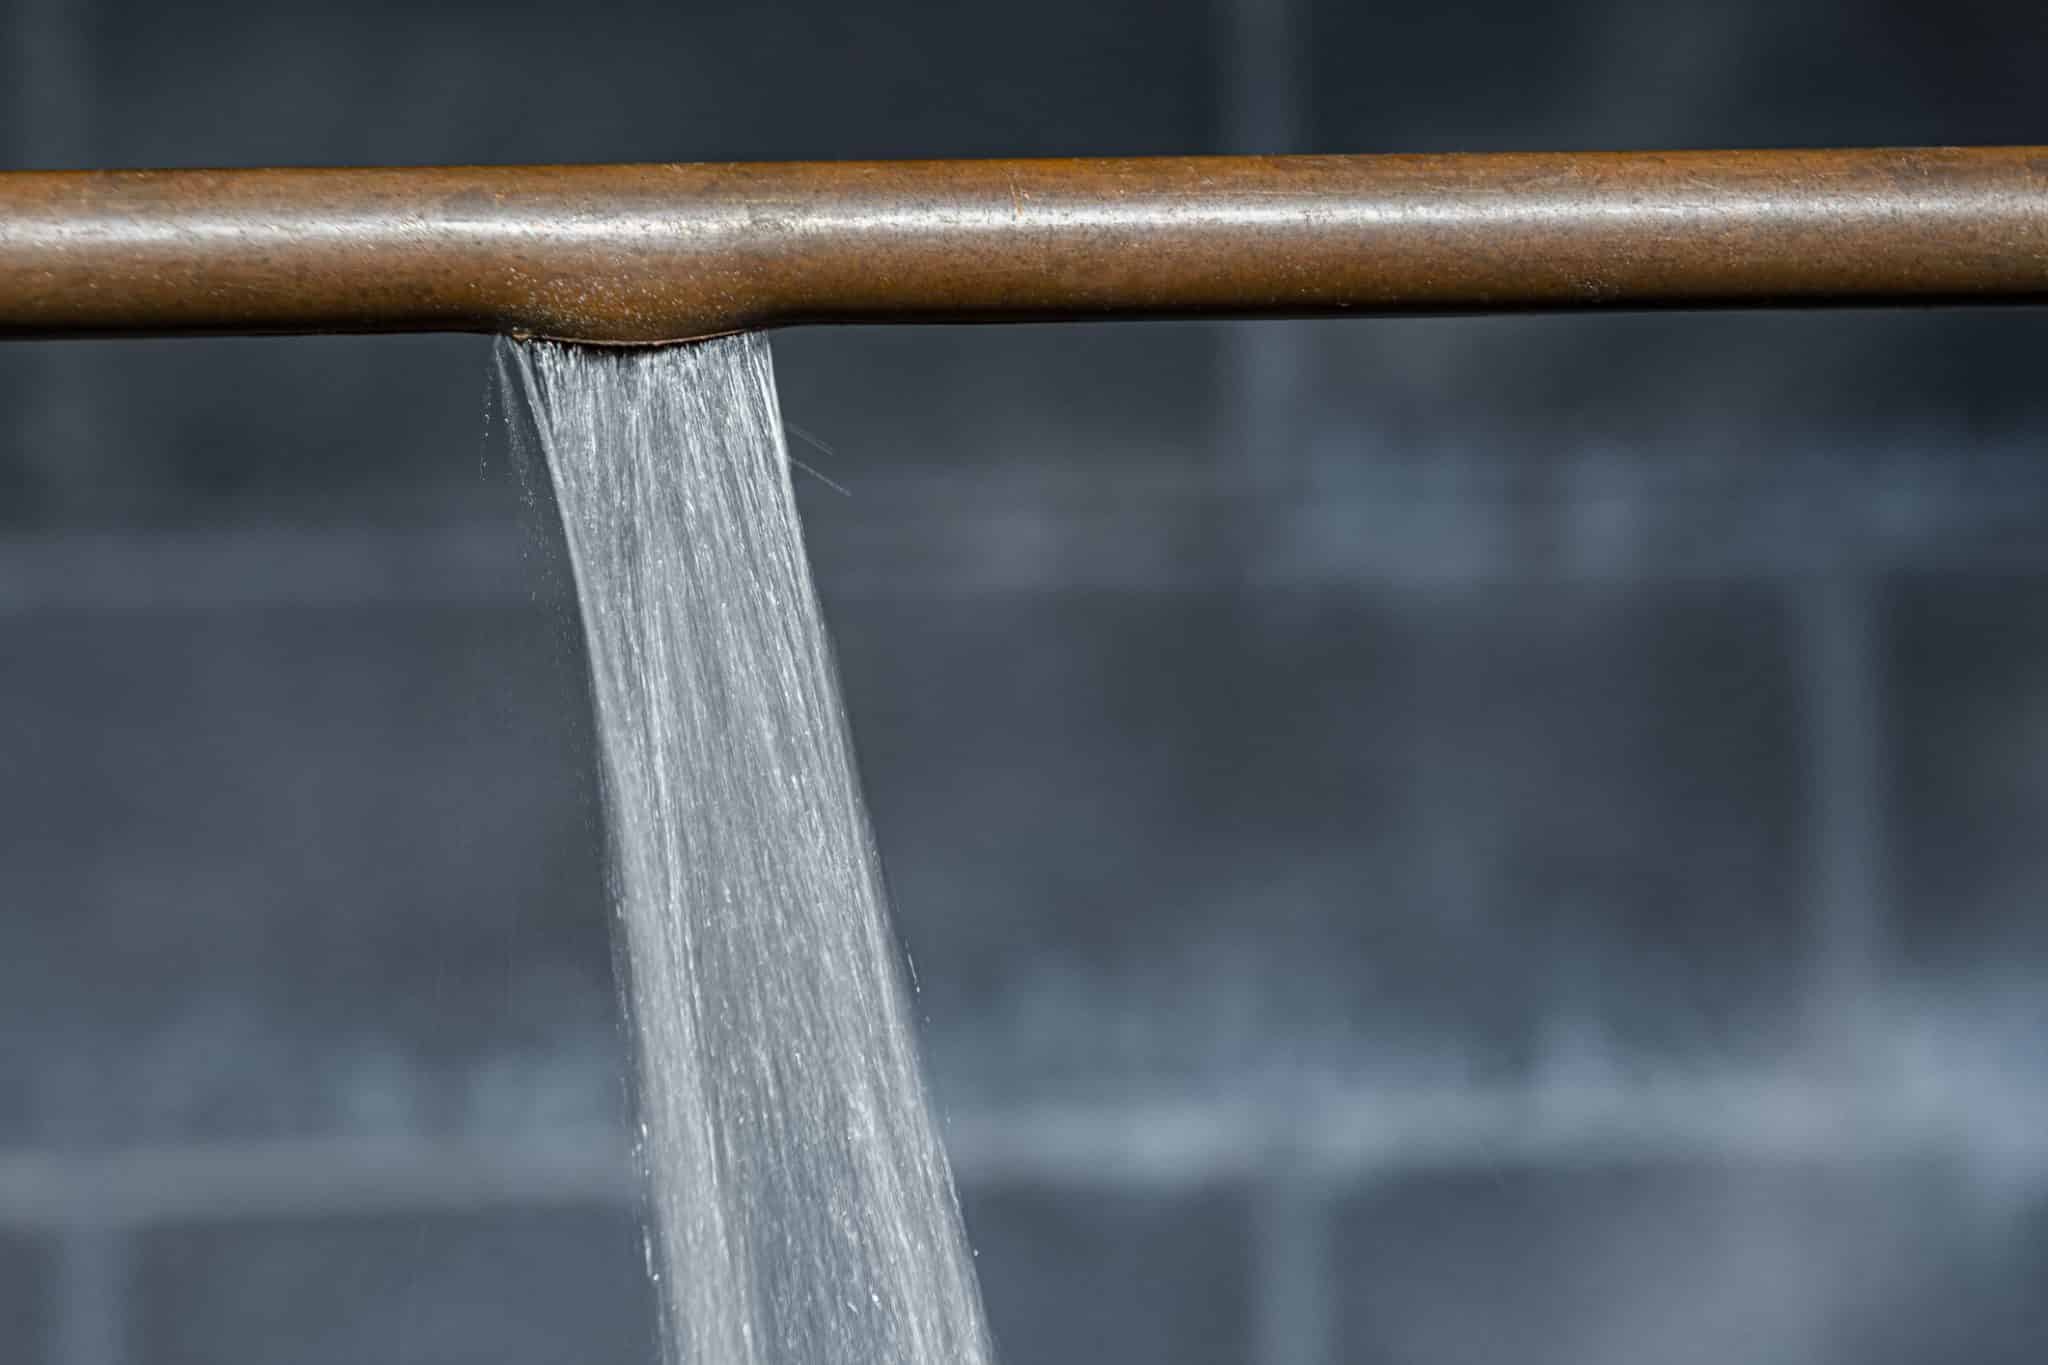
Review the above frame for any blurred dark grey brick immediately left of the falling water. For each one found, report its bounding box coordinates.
[0,601,623,1142]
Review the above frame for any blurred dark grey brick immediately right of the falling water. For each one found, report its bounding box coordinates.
[834,587,1804,1101]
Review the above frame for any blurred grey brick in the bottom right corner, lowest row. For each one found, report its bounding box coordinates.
[1337,1164,2048,1365]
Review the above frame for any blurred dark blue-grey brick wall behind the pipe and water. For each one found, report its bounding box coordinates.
[0,0,2048,1365]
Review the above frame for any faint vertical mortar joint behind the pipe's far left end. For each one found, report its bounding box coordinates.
[0,0,102,512]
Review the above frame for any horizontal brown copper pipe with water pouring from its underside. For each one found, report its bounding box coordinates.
[0,147,2048,344]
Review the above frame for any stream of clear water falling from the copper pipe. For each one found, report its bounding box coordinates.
[500,336,989,1365]
